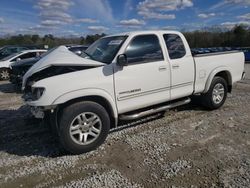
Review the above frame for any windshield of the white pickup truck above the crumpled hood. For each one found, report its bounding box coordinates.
[81,36,127,64]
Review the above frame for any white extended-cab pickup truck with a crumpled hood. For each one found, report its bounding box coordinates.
[23,31,244,154]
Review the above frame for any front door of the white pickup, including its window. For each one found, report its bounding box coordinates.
[114,34,170,113]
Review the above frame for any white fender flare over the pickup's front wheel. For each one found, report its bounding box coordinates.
[52,88,118,125]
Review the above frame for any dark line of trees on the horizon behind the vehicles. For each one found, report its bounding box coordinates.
[0,25,250,48]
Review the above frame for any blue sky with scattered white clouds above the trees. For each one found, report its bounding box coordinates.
[0,0,250,36]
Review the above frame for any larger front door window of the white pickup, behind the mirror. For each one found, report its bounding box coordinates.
[125,34,164,64]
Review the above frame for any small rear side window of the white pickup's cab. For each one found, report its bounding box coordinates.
[163,34,186,59]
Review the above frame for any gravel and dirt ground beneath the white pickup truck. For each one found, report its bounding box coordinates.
[0,65,250,188]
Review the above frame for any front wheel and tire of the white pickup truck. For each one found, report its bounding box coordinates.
[59,101,110,154]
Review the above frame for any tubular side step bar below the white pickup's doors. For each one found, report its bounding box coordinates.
[119,98,191,121]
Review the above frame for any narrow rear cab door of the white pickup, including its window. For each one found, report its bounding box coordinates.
[163,33,195,100]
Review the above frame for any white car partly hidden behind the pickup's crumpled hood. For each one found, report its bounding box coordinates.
[0,50,47,80]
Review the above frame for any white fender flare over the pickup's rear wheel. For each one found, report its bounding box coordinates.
[203,66,232,93]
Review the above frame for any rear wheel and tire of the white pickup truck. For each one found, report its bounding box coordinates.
[201,77,228,110]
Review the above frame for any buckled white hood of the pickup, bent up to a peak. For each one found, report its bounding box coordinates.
[23,46,105,86]
